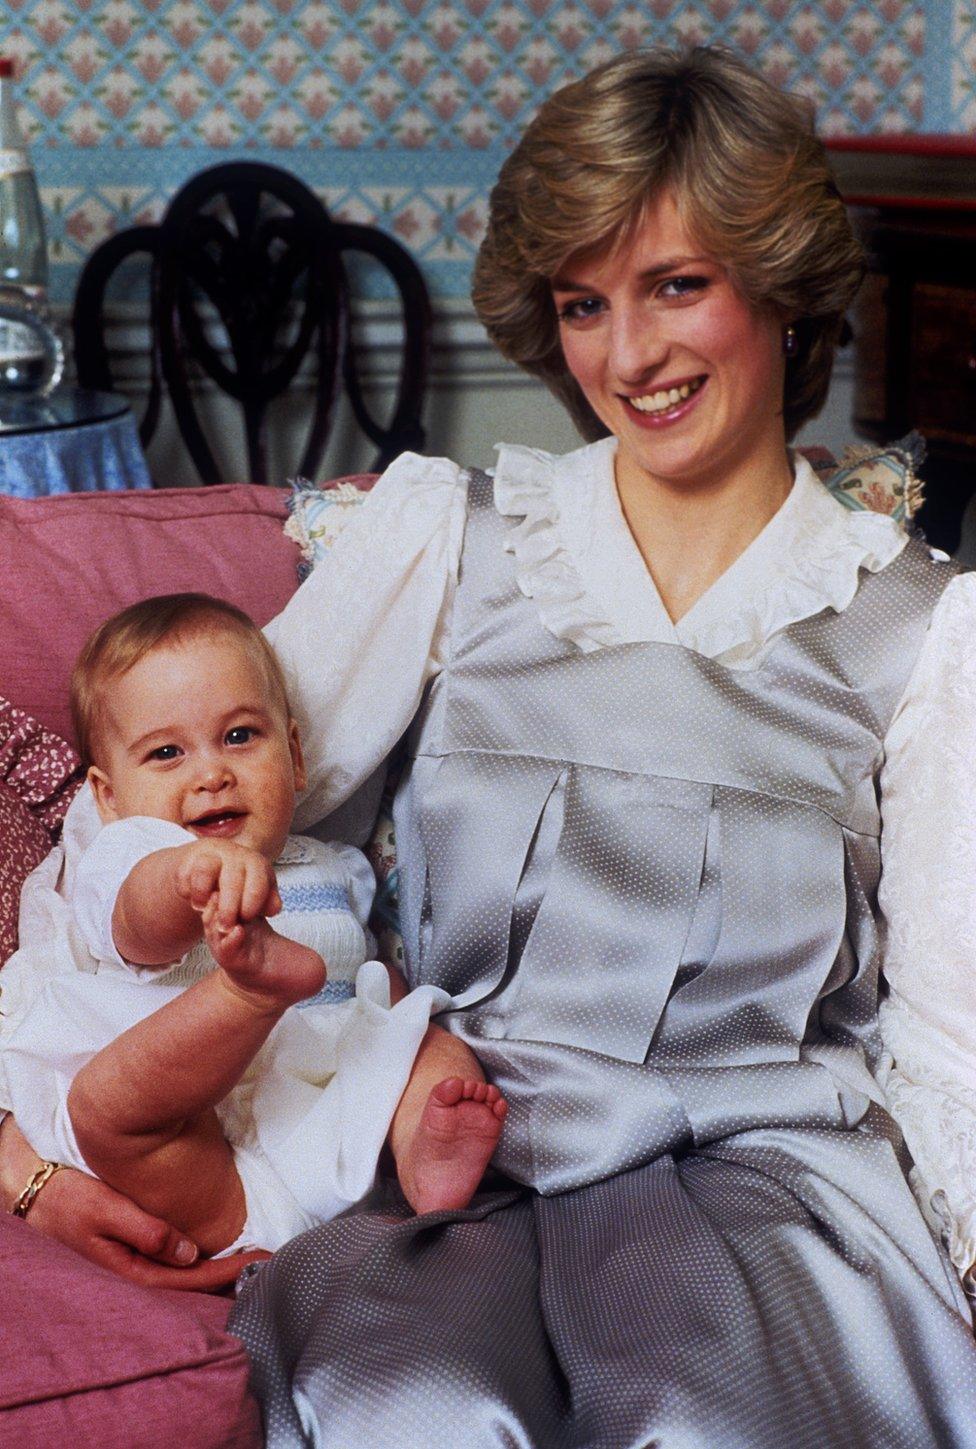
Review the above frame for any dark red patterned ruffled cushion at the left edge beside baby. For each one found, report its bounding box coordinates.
[0,700,83,962]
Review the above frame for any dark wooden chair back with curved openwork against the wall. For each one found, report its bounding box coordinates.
[74,161,430,483]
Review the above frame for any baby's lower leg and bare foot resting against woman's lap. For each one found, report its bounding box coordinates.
[390,1026,508,1213]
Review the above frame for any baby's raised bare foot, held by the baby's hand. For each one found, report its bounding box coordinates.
[204,911,326,1009]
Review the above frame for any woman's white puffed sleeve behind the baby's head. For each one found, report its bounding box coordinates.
[265,454,466,829]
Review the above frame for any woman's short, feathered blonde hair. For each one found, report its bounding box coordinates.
[472,46,864,439]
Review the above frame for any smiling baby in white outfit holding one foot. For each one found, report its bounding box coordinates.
[3,594,505,1253]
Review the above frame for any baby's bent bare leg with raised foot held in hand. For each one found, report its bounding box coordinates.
[68,919,324,1253]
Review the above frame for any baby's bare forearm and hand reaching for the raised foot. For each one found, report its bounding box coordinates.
[112,840,281,966]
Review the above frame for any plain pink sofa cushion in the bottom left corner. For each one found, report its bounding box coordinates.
[0,1214,262,1449]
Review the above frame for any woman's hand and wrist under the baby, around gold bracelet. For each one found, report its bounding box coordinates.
[0,1117,269,1293]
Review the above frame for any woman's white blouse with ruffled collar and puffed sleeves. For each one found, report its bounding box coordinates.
[266,438,976,1277]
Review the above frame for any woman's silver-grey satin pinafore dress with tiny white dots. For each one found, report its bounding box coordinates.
[232,472,976,1449]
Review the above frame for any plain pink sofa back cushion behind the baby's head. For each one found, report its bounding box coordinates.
[0,484,298,739]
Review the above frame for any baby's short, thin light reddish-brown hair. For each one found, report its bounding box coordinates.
[71,594,291,765]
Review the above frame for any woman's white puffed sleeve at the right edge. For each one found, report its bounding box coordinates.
[880,574,976,1293]
